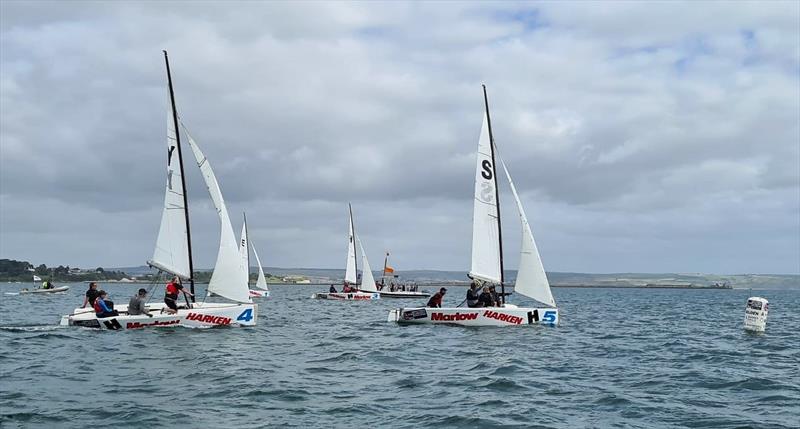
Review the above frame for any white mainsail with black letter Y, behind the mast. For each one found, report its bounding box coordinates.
[147,103,192,279]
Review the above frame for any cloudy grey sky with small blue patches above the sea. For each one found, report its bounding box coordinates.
[0,0,800,274]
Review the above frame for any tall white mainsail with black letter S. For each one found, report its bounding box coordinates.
[470,114,501,283]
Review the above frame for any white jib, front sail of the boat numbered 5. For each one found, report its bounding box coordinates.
[500,159,556,307]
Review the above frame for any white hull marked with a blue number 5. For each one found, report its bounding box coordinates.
[387,304,558,326]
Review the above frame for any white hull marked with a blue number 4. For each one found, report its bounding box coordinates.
[61,303,258,330]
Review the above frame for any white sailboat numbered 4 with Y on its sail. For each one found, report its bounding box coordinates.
[61,51,258,330]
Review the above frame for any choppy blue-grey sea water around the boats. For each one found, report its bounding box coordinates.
[0,284,800,428]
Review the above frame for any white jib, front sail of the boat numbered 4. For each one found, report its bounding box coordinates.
[183,126,252,303]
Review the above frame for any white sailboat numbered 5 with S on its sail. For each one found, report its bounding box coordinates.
[388,86,558,326]
